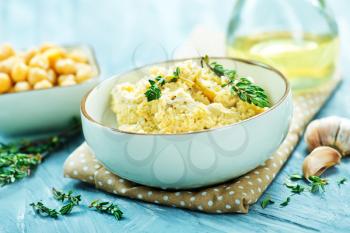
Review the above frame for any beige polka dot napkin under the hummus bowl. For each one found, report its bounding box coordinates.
[64,79,339,213]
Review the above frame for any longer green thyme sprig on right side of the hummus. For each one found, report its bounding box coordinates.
[201,55,270,108]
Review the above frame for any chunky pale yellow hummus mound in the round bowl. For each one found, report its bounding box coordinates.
[111,60,266,134]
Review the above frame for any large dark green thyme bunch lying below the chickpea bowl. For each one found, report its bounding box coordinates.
[0,121,80,186]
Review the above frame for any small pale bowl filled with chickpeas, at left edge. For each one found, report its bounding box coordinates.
[0,43,99,135]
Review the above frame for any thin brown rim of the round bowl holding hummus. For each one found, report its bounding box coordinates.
[80,56,291,136]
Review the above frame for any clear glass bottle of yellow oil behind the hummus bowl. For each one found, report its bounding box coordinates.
[227,0,339,90]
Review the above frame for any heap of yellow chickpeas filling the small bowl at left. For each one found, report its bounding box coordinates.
[0,43,95,93]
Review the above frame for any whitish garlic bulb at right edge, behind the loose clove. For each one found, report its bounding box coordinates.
[305,116,350,156]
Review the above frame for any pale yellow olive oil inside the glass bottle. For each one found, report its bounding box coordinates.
[228,32,339,89]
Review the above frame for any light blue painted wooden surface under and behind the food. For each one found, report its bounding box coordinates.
[0,0,350,233]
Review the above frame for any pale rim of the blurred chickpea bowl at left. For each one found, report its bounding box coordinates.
[0,44,101,98]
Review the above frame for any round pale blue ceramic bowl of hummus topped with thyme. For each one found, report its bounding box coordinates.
[81,58,292,189]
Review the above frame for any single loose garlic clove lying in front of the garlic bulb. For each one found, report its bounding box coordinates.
[303,146,341,179]
